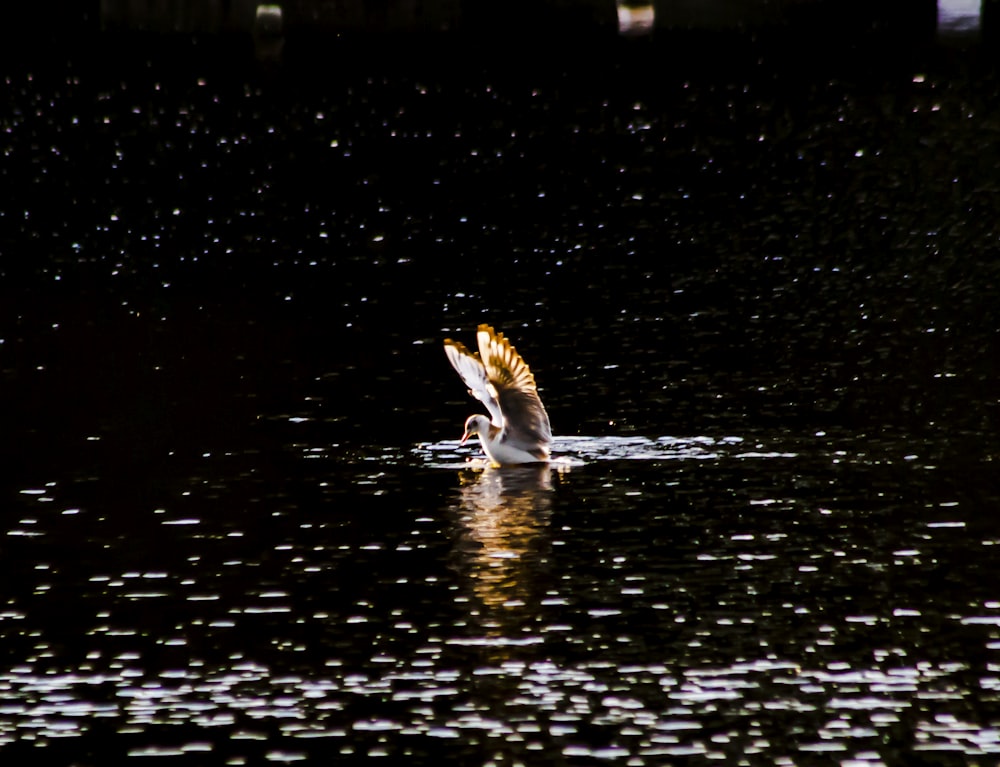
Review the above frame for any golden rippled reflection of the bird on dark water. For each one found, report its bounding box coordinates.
[454,466,553,637]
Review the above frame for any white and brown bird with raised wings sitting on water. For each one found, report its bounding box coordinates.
[444,325,552,466]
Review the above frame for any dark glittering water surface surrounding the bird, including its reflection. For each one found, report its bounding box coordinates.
[0,40,1000,766]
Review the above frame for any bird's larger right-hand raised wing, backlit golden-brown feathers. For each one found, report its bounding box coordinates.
[474,325,552,452]
